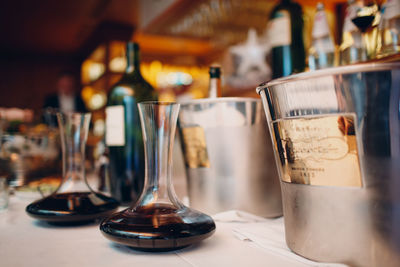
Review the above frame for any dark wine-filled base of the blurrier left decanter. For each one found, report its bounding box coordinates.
[26,192,119,224]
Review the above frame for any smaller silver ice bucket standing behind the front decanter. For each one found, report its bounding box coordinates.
[178,98,282,217]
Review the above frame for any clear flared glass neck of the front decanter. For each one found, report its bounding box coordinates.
[136,102,182,207]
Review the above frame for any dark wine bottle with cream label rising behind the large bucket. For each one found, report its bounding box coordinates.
[268,0,305,78]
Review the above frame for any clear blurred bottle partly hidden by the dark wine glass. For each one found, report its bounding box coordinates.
[340,0,366,65]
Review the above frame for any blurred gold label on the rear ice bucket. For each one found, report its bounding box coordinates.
[182,126,210,168]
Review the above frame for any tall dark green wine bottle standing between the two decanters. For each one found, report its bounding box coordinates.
[105,43,157,204]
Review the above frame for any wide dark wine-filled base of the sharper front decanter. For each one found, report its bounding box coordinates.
[100,203,215,252]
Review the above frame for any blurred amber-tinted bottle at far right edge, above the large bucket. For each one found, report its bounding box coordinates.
[378,0,400,57]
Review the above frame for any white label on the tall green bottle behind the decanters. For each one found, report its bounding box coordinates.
[106,105,125,146]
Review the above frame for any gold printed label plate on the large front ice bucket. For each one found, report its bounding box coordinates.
[273,114,362,187]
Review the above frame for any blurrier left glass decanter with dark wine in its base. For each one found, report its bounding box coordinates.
[26,113,119,223]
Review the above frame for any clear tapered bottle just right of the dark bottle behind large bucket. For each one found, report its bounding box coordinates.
[308,3,335,70]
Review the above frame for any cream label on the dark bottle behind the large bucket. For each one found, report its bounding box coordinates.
[268,10,292,47]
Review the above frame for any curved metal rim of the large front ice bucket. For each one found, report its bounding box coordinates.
[256,62,400,94]
